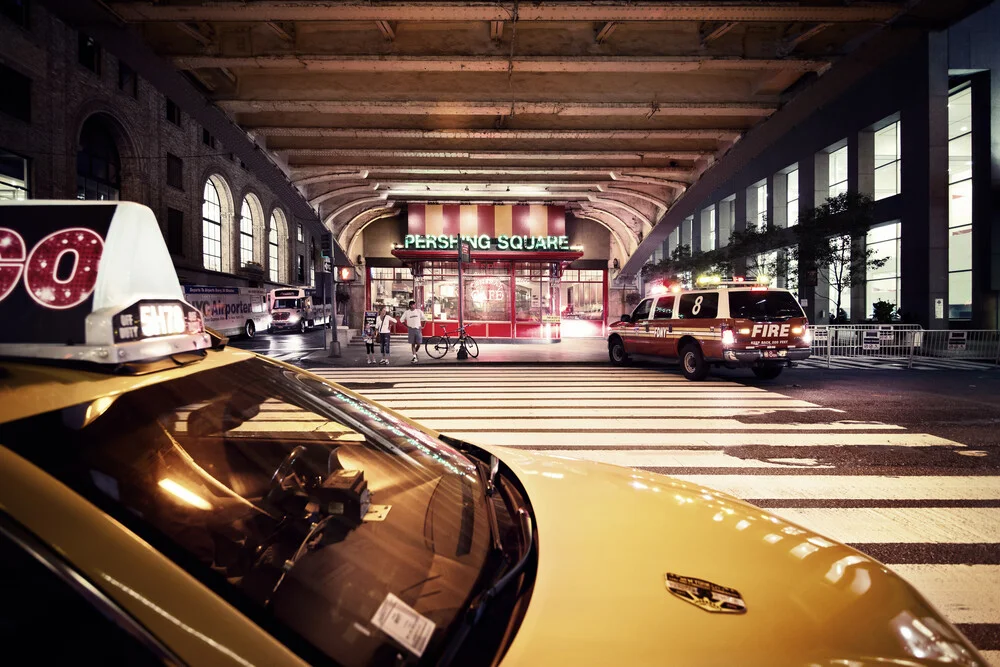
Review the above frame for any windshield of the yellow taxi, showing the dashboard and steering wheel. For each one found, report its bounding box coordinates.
[3,358,491,665]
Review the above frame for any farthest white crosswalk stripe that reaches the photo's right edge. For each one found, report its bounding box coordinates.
[664,475,1000,500]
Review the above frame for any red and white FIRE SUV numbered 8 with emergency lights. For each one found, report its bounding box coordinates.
[608,282,812,380]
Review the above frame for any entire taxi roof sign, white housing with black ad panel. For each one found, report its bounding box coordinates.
[0,201,211,364]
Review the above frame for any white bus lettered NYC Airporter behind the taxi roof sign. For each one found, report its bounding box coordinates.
[184,285,271,338]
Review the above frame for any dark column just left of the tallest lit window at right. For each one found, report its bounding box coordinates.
[900,32,948,329]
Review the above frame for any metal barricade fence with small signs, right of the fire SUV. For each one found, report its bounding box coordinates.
[812,324,1000,367]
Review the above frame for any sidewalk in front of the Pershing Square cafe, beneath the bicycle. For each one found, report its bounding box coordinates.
[300,335,608,367]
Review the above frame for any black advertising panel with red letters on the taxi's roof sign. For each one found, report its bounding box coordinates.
[0,205,117,345]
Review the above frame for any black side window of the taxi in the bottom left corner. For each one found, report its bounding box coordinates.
[0,520,174,667]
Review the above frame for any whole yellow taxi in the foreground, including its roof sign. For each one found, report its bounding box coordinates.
[0,202,985,667]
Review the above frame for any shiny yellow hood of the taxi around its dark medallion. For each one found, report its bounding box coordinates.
[488,447,985,666]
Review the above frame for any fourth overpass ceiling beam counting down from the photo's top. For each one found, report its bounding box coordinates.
[243,129,740,142]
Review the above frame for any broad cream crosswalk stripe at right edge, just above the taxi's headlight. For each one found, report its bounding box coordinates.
[892,565,1000,623]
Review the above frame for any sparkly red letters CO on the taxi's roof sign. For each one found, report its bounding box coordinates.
[0,227,104,310]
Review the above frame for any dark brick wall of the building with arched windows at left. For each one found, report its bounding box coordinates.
[0,3,321,285]
